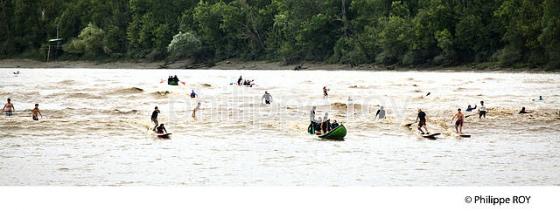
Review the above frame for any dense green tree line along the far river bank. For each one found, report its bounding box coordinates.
[0,0,560,68]
